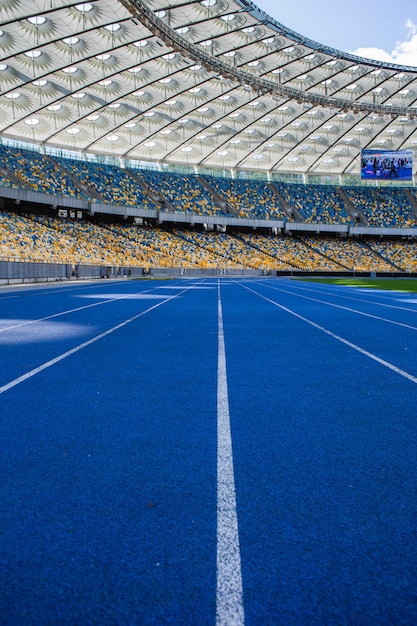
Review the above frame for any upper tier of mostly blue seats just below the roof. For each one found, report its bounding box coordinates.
[0,145,417,228]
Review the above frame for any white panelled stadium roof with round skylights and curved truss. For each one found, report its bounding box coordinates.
[0,0,417,174]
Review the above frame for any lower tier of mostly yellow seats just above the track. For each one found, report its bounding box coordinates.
[0,211,417,272]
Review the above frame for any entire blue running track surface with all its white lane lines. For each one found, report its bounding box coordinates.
[0,279,417,626]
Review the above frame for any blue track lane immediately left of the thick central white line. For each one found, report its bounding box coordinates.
[0,284,217,625]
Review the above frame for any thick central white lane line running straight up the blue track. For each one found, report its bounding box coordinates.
[216,283,245,626]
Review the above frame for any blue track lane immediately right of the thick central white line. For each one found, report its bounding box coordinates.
[223,282,417,626]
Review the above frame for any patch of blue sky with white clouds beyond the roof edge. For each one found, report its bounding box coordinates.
[253,0,417,67]
